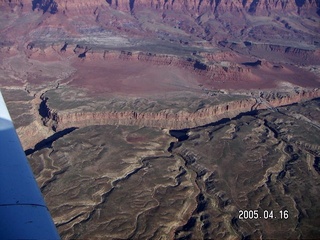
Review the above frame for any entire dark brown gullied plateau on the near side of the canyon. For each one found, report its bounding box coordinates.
[29,100,320,239]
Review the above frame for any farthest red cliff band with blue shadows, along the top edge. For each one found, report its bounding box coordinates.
[0,0,320,15]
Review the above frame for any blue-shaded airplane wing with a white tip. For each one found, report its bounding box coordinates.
[0,92,60,239]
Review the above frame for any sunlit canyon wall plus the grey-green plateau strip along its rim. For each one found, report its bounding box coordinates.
[44,88,320,129]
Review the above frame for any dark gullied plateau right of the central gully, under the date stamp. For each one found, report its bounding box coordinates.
[173,98,320,239]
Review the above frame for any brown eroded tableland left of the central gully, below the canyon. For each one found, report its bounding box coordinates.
[30,126,198,238]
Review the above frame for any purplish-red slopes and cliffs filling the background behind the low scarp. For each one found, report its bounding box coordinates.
[0,0,320,64]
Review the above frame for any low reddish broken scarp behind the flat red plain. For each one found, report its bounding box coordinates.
[24,44,254,81]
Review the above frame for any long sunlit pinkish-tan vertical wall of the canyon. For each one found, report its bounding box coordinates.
[41,89,320,130]
